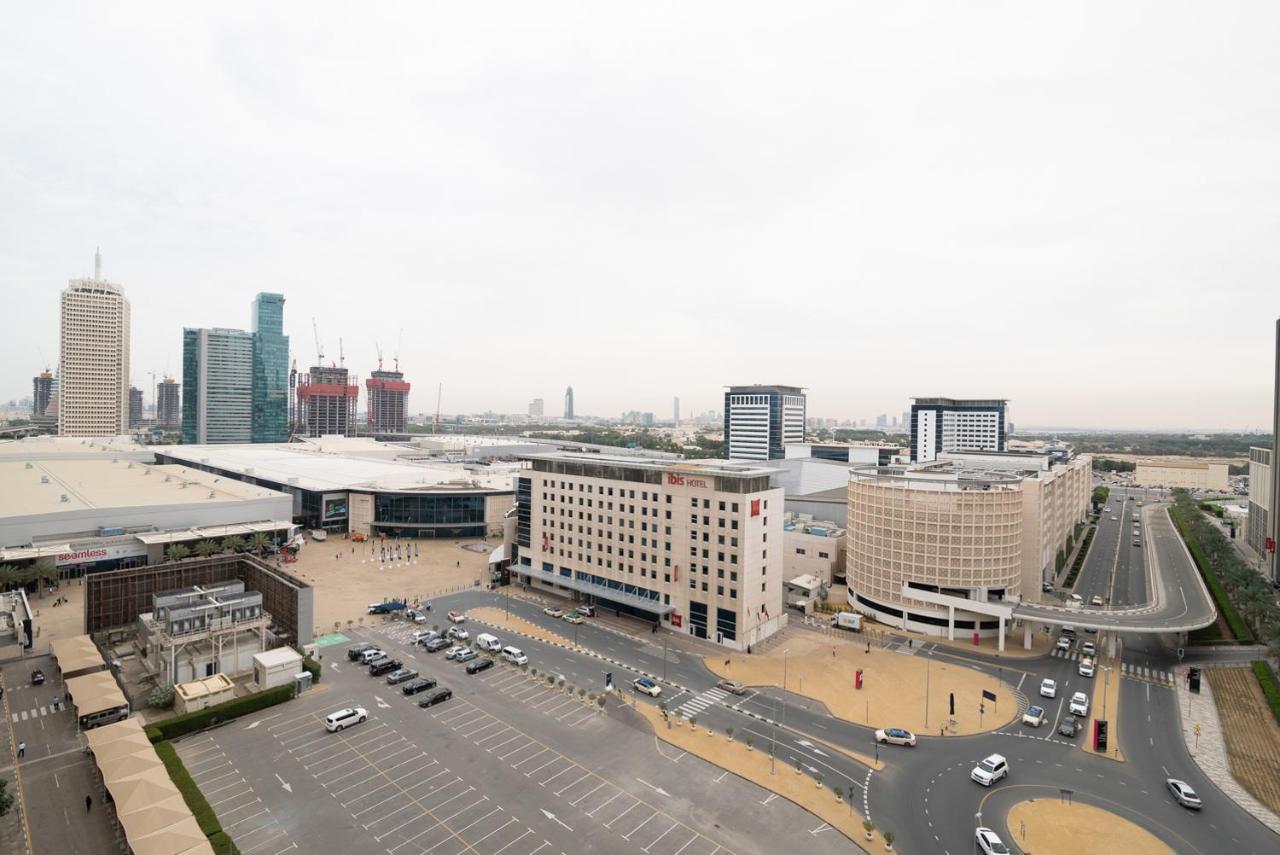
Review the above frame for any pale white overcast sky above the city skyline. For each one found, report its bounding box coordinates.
[0,1,1280,429]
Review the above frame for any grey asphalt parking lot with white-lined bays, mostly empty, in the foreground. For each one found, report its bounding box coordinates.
[170,627,849,855]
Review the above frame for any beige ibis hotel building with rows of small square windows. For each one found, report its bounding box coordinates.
[511,452,786,650]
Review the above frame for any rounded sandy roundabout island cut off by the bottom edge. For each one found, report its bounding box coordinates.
[997,799,1174,855]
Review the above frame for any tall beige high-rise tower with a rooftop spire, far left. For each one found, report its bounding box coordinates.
[58,252,129,436]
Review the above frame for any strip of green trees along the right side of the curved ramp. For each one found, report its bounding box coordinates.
[1174,490,1280,657]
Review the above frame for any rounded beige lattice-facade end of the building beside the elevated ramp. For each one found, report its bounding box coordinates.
[846,466,1024,637]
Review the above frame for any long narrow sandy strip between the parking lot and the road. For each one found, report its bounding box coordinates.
[635,704,878,843]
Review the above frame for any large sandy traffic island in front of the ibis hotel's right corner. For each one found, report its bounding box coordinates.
[705,634,1018,735]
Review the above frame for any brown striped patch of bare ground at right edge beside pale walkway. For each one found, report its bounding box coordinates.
[1204,668,1280,813]
